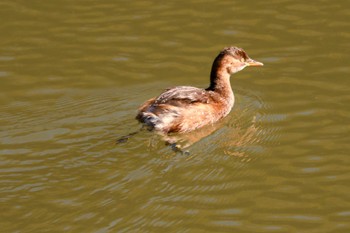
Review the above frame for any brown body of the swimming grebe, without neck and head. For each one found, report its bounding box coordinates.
[136,86,232,133]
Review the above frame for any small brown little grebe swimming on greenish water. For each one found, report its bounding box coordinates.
[136,47,263,134]
